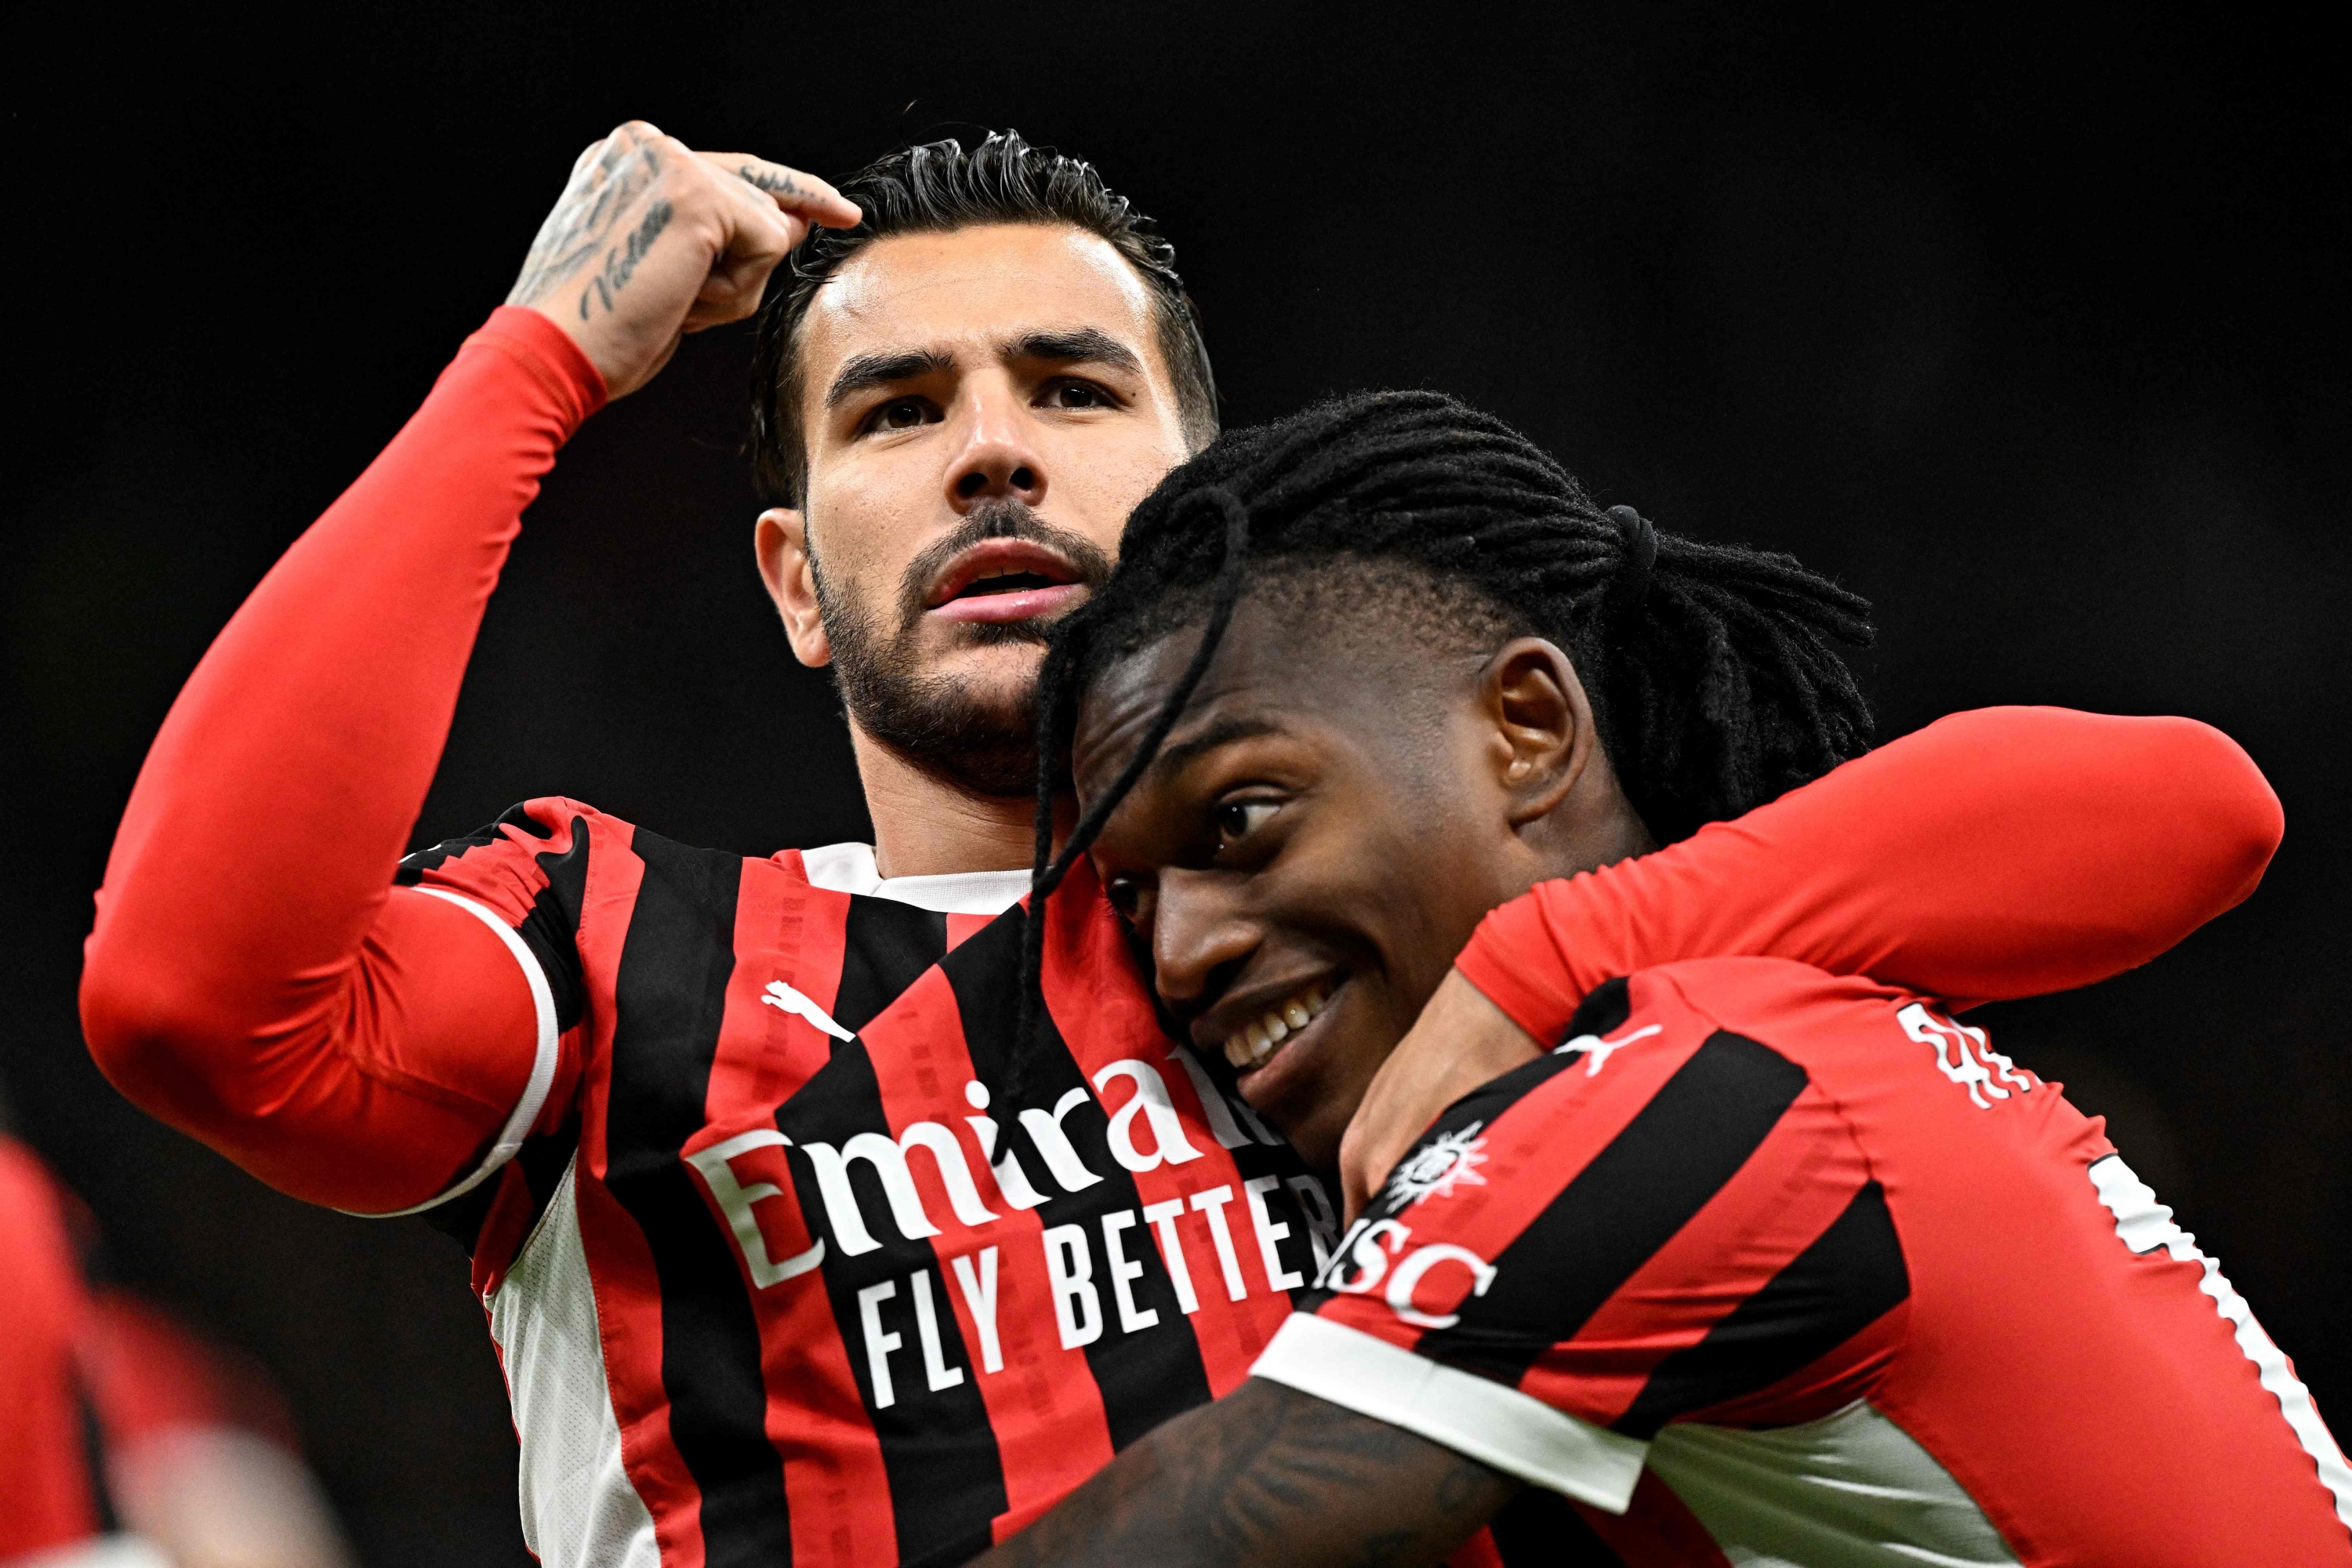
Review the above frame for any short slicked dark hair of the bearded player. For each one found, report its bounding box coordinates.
[750,132,1216,506]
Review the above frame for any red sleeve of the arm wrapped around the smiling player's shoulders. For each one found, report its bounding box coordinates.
[1456,708,2284,1041]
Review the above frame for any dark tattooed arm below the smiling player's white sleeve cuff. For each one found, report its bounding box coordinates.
[976,1377,1519,1568]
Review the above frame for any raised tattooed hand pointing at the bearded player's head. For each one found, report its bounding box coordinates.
[506,120,861,397]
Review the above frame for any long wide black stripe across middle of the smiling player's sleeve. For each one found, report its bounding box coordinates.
[1418,1029,1806,1385]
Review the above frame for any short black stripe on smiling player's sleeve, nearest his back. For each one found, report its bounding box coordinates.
[1616,1182,1910,1439]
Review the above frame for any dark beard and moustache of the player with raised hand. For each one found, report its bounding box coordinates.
[809,501,1110,799]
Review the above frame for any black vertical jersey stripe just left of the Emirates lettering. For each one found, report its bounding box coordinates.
[604,832,793,1568]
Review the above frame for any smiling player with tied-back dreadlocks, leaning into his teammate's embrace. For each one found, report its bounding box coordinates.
[985,393,2352,1568]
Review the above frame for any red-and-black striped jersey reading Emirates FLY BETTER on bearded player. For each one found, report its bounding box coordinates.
[400,799,1336,1568]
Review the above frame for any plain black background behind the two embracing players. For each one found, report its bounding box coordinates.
[0,2,2352,1566]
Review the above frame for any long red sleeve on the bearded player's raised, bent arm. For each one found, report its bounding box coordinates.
[82,308,604,1213]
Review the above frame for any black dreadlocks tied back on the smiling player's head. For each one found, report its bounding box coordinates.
[1021,393,1872,1067]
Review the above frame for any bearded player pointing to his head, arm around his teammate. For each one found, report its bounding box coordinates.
[82,125,2277,1566]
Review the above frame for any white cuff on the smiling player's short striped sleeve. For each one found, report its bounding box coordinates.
[1249,1312,1649,1514]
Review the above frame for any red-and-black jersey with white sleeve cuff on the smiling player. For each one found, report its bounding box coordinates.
[1256,959,2352,1568]
